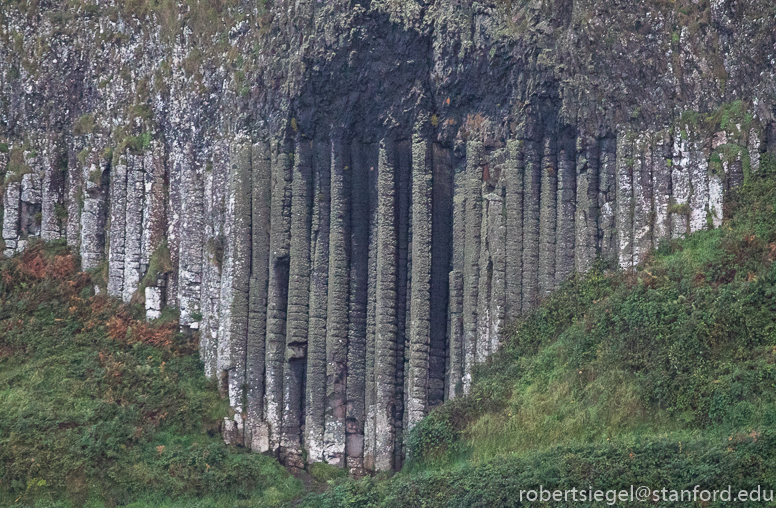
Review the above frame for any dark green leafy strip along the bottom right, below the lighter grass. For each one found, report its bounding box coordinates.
[302,431,776,508]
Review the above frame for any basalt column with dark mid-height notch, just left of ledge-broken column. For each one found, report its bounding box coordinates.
[264,143,293,453]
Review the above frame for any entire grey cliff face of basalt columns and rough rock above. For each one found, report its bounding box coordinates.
[0,0,776,475]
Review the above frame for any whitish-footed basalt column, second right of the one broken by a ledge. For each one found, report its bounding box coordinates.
[323,134,352,467]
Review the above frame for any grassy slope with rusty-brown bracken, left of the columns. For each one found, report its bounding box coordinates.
[0,244,301,507]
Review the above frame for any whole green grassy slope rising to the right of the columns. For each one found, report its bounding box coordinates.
[306,165,776,508]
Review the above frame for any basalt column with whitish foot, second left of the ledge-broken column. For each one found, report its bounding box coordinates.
[250,142,272,452]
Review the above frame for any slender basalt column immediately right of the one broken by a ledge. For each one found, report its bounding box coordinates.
[304,140,332,463]
